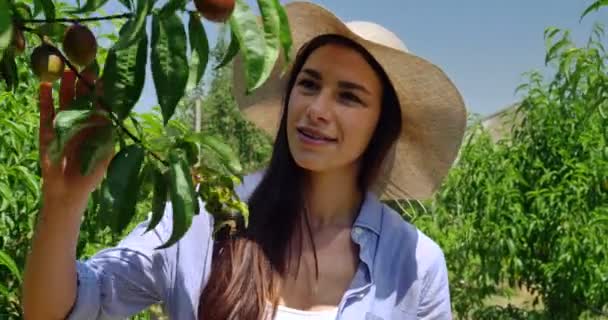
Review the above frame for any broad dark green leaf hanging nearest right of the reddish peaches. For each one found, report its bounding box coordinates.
[102,25,148,120]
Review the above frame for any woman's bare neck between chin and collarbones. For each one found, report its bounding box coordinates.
[306,168,363,231]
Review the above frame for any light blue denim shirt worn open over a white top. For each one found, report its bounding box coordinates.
[68,173,452,320]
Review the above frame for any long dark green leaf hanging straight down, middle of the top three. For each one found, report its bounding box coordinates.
[152,14,188,125]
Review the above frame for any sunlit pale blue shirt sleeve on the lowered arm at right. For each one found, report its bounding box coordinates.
[418,232,452,320]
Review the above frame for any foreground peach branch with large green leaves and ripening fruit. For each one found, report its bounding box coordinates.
[0,0,291,248]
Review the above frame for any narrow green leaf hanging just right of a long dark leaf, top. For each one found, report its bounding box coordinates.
[188,13,209,88]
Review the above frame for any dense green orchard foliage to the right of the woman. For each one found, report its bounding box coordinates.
[411,18,608,319]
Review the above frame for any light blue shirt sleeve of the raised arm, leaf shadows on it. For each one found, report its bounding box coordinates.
[67,203,175,319]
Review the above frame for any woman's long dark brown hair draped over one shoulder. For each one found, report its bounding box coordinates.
[198,34,401,320]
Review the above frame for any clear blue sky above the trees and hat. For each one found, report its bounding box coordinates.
[97,0,608,115]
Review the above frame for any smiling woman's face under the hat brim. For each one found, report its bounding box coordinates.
[287,44,382,172]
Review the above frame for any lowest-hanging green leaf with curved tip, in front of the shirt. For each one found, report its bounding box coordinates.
[156,149,198,249]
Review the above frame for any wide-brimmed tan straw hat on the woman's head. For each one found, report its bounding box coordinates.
[234,2,466,200]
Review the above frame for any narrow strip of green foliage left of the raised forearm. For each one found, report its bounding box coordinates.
[0,43,40,317]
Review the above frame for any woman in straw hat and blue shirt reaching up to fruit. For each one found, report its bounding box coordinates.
[24,2,465,320]
